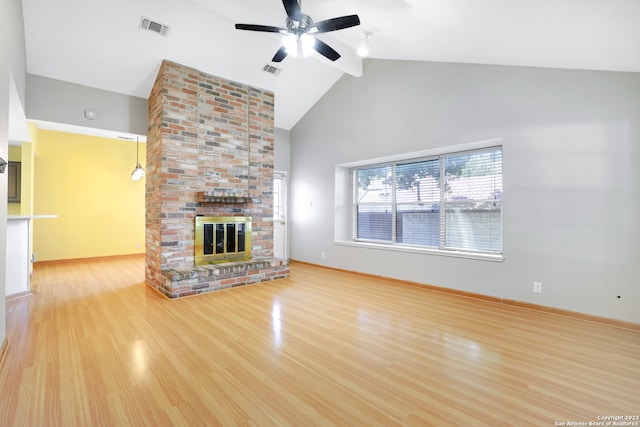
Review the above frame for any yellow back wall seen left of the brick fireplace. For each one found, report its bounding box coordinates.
[33,130,146,261]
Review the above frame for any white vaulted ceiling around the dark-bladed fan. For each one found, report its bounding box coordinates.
[22,0,640,129]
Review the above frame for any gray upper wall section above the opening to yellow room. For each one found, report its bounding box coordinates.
[26,74,148,135]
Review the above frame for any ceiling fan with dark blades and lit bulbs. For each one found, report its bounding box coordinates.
[236,0,360,62]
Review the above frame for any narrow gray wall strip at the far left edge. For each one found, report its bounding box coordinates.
[0,0,27,345]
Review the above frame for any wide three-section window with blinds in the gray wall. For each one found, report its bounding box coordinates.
[353,147,502,254]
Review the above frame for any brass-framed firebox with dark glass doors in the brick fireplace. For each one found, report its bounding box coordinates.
[195,216,251,265]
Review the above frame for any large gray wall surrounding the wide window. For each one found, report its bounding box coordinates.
[290,60,640,323]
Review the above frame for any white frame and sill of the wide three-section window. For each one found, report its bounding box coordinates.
[350,145,504,261]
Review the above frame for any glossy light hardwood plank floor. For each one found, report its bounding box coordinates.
[0,258,640,426]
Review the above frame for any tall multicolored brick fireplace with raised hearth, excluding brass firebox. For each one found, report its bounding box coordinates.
[145,61,289,298]
